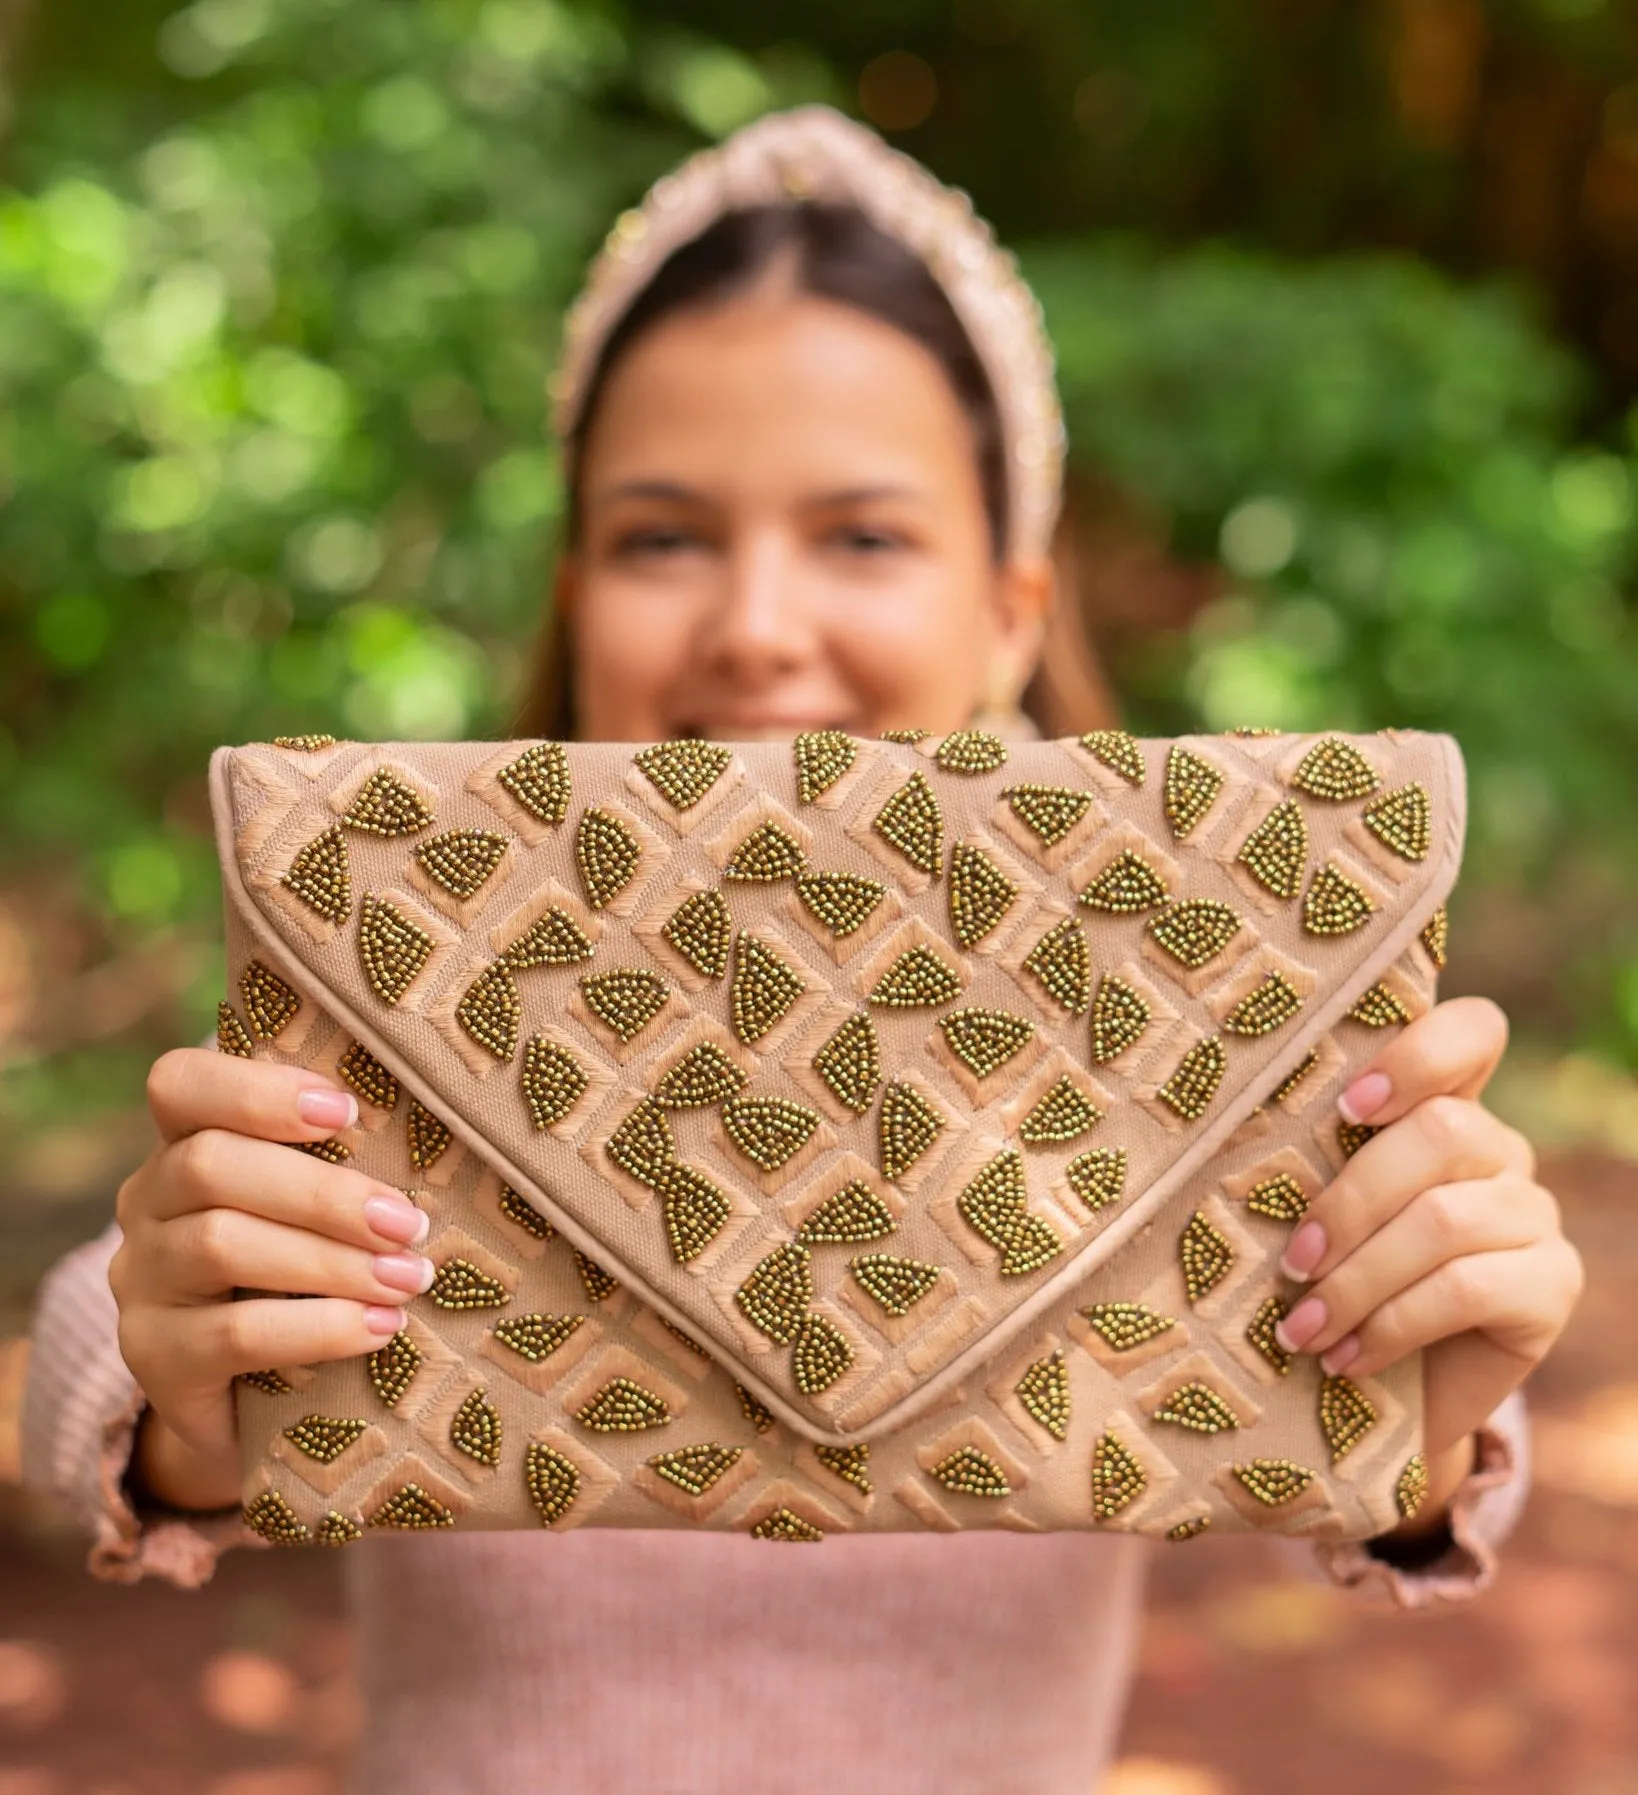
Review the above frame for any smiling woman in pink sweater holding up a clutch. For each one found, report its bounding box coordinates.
[25,108,1581,1795]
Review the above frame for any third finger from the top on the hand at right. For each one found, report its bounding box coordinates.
[1276,1174,1557,1353]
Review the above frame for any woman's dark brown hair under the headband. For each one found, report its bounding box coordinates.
[517,201,1107,741]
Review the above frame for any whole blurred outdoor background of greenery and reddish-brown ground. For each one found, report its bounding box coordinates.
[0,0,1638,1795]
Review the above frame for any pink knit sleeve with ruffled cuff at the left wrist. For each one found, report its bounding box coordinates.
[23,1226,264,1589]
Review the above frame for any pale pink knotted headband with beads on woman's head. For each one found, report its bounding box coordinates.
[549,106,1066,556]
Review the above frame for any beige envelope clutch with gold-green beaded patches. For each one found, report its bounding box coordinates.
[212,731,1464,1545]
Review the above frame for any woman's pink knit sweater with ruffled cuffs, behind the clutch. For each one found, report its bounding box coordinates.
[23,1228,1529,1795]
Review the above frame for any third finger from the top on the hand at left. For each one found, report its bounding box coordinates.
[149,1210,434,1305]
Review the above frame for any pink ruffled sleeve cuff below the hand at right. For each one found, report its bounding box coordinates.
[1313,1391,1530,1608]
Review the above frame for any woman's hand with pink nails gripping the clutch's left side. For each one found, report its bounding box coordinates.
[108,1048,432,1510]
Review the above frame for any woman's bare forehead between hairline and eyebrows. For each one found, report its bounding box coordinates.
[581,293,981,503]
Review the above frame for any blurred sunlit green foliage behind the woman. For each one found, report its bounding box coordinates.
[0,0,1638,1120]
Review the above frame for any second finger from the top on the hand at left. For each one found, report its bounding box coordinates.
[144,1127,431,1248]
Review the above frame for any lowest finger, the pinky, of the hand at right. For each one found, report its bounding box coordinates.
[1291,1235,1581,1382]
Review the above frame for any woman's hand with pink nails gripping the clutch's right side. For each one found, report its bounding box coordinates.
[1277,998,1582,1531]
